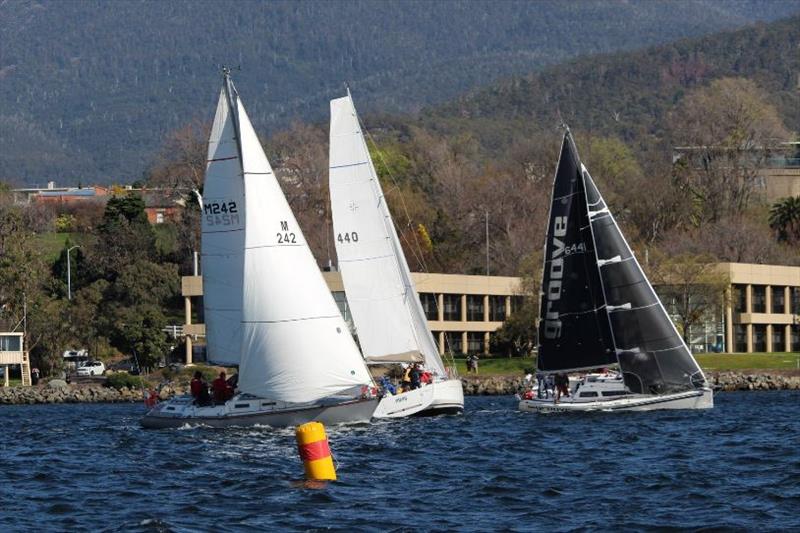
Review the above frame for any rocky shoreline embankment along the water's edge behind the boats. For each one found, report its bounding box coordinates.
[0,371,800,405]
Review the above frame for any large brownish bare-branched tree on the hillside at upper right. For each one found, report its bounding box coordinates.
[670,78,789,224]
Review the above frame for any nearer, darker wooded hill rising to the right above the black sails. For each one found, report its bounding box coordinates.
[428,16,800,151]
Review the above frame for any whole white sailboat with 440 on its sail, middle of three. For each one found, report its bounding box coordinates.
[330,91,464,418]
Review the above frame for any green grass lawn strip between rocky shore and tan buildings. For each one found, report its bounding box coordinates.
[456,353,800,376]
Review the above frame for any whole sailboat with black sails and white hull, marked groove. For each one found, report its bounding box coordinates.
[519,131,714,412]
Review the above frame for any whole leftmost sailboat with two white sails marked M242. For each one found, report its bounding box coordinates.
[142,71,378,428]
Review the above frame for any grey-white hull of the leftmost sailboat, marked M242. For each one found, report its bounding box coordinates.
[141,397,378,429]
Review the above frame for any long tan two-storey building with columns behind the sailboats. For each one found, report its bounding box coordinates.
[182,263,800,362]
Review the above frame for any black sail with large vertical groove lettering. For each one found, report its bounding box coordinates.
[537,132,617,372]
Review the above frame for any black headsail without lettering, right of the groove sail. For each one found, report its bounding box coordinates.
[581,165,705,394]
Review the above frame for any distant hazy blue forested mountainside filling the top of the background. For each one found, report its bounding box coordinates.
[0,0,800,184]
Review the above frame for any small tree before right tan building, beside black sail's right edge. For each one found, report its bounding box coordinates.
[651,254,730,345]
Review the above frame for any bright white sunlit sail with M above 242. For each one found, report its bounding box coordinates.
[204,76,372,402]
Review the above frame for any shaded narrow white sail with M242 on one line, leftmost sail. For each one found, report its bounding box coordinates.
[201,88,245,365]
